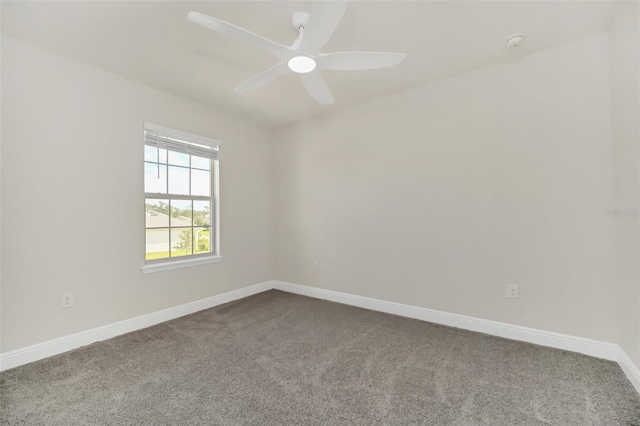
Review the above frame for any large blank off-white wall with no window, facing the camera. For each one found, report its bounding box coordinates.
[273,34,617,342]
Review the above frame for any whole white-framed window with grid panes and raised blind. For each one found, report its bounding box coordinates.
[142,123,221,272]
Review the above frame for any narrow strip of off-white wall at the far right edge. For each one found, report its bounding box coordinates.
[609,2,640,368]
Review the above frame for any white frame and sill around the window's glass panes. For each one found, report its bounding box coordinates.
[141,123,222,274]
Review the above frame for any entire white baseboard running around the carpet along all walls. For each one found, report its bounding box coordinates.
[0,280,640,393]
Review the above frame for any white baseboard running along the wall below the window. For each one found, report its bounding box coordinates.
[0,281,274,371]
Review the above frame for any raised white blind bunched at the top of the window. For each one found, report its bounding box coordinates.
[144,123,220,160]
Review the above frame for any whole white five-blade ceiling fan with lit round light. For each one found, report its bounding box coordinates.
[188,0,406,105]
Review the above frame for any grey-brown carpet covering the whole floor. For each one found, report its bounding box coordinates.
[0,291,640,426]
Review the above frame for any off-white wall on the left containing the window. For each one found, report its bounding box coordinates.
[0,36,273,352]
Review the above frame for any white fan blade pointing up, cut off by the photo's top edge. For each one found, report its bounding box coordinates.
[300,0,347,54]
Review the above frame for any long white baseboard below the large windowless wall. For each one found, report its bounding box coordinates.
[275,281,619,361]
